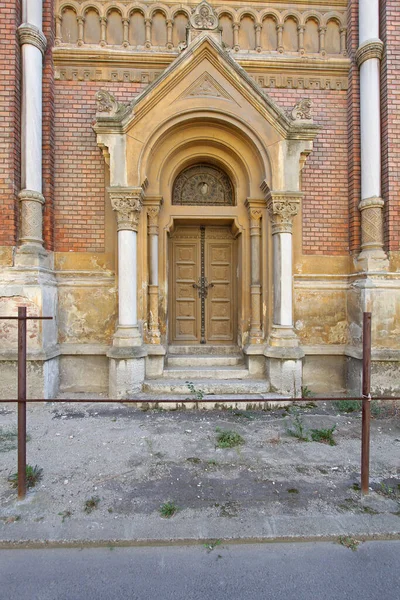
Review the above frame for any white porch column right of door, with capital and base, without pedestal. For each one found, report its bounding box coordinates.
[267,192,302,347]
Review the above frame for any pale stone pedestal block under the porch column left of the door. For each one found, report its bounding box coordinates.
[107,347,146,400]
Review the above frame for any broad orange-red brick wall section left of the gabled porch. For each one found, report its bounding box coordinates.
[54,81,143,252]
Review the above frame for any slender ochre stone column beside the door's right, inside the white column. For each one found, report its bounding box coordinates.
[246,198,265,344]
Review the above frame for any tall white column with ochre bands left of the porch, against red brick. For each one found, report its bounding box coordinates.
[18,0,46,254]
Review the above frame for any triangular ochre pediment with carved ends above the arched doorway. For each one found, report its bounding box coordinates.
[94,32,318,140]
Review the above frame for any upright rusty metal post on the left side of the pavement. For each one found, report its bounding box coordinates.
[18,306,26,500]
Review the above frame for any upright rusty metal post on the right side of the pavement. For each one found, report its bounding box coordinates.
[361,312,371,496]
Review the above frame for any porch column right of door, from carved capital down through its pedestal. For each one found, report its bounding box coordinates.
[265,191,304,397]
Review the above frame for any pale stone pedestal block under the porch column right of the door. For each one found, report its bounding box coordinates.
[264,347,304,398]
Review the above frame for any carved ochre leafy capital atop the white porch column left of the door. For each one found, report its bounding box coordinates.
[107,186,143,231]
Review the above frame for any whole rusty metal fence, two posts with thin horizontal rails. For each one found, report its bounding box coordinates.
[0,306,400,500]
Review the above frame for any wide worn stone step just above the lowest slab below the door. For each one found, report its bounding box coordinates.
[143,379,270,399]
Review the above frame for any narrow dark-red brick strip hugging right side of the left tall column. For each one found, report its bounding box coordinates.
[42,0,55,250]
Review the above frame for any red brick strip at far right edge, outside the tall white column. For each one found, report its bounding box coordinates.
[381,0,400,251]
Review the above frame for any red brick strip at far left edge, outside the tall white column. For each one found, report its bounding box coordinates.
[0,0,21,246]
